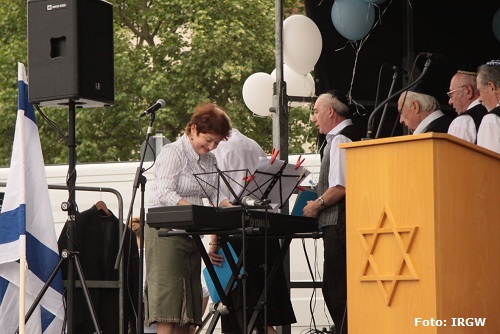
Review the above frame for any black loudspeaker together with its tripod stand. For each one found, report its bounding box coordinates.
[28,0,114,334]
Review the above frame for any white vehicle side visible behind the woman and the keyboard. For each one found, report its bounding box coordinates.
[0,154,331,333]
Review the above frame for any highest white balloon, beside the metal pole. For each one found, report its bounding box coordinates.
[283,15,323,75]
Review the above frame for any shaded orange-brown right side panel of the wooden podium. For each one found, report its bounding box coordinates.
[434,140,500,333]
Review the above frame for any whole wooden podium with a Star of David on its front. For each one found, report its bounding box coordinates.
[341,133,500,334]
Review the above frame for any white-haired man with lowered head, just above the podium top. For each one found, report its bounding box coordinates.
[398,85,453,135]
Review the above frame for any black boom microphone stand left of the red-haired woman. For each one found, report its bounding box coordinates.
[115,111,155,334]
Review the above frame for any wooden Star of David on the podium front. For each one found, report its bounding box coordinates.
[358,204,419,306]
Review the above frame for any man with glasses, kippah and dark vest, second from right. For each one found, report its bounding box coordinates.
[446,66,487,144]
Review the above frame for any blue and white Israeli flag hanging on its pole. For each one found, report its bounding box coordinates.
[0,63,64,334]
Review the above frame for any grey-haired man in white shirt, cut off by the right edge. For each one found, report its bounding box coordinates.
[476,60,500,153]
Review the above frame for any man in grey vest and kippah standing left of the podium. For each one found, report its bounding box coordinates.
[303,90,363,334]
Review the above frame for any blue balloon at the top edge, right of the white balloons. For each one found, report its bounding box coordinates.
[331,0,375,41]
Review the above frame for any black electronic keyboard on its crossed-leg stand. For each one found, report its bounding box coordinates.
[148,205,322,334]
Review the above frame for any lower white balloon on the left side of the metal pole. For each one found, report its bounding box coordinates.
[243,72,275,116]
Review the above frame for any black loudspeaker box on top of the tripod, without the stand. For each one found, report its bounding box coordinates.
[28,0,114,108]
